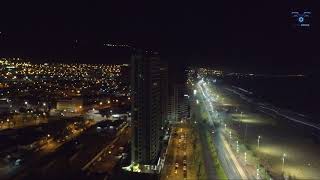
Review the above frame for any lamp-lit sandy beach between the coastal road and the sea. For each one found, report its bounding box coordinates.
[203,79,320,179]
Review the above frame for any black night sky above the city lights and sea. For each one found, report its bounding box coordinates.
[0,0,320,70]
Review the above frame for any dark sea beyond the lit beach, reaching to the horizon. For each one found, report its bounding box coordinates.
[226,76,320,122]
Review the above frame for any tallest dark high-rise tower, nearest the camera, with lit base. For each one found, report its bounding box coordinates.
[131,53,162,165]
